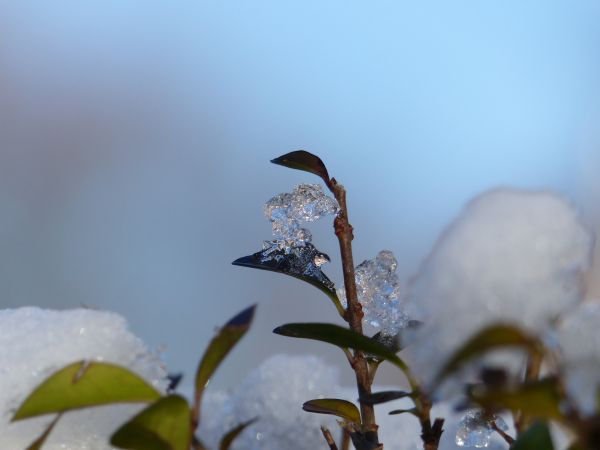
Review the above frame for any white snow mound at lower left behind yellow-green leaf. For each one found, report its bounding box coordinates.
[0,308,166,450]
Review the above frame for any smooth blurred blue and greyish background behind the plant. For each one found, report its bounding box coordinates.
[0,0,600,386]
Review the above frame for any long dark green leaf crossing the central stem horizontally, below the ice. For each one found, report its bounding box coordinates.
[273,323,407,371]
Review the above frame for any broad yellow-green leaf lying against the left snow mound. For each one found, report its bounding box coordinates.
[12,361,160,420]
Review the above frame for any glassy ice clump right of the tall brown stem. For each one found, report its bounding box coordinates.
[338,250,408,336]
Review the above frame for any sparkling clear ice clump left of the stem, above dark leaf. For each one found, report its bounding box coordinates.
[264,184,339,250]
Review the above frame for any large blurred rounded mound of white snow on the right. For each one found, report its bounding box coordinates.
[409,189,593,390]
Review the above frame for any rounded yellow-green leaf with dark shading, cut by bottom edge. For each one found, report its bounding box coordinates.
[110,394,192,450]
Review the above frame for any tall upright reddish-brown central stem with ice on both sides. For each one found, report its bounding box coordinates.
[329,178,379,444]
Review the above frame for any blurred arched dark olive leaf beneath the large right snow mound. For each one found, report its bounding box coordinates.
[434,324,542,385]
